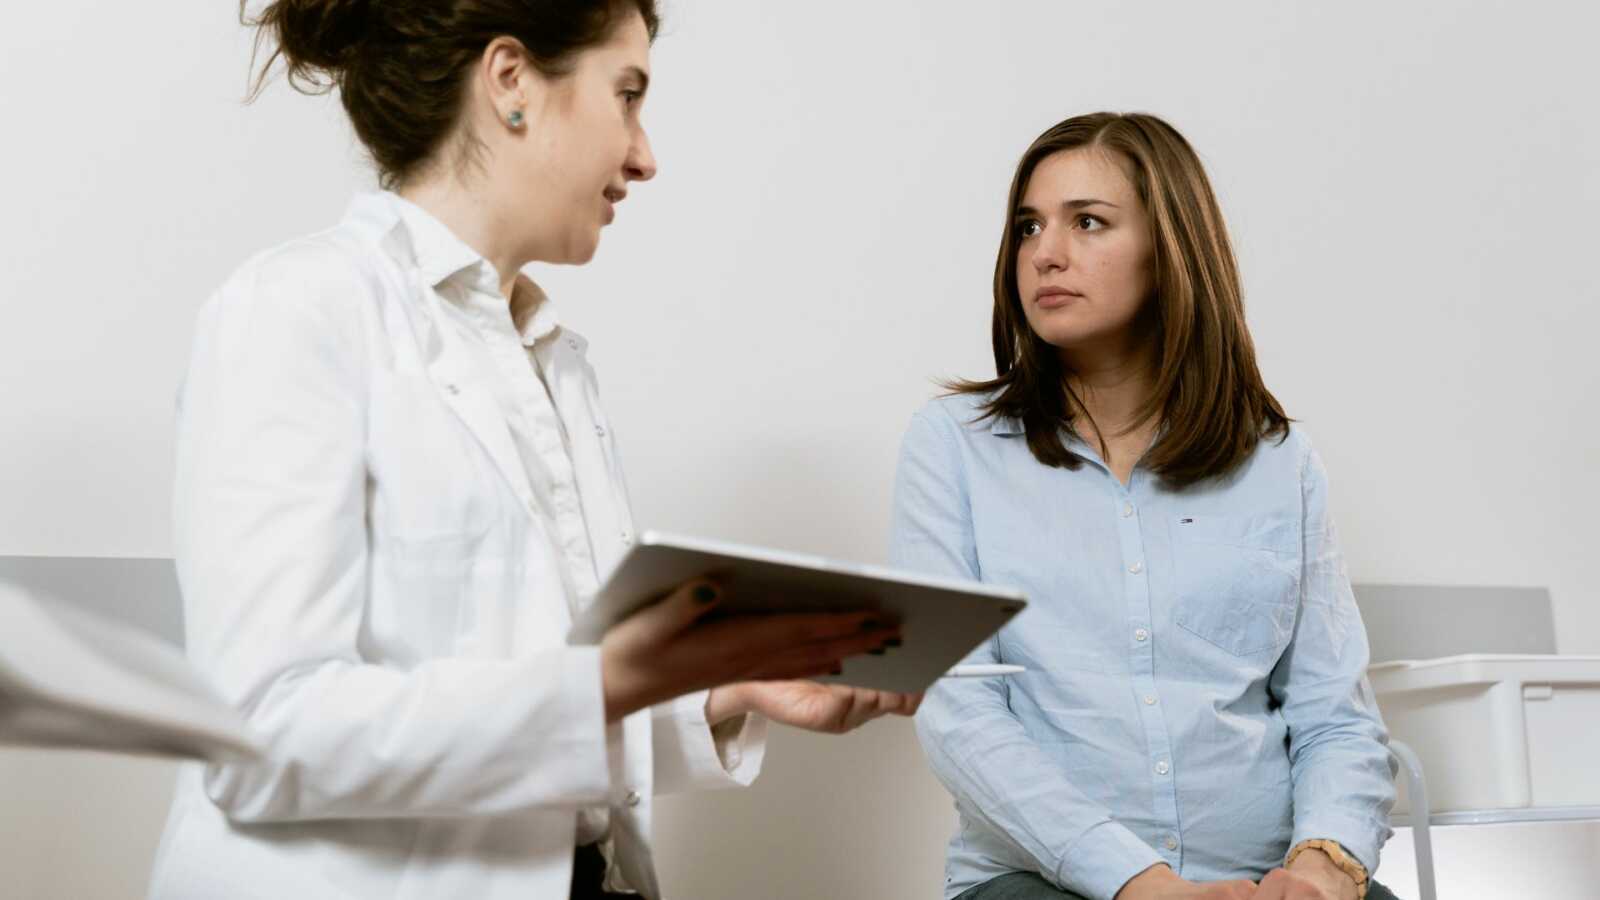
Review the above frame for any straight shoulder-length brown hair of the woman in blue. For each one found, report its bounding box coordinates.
[947,112,1290,487]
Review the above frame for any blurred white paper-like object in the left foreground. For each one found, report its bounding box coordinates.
[0,581,261,759]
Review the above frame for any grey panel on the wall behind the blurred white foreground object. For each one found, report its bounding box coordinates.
[0,556,184,647]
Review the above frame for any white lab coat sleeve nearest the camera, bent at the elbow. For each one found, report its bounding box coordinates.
[174,243,611,823]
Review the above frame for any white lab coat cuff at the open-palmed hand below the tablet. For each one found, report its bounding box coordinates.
[651,690,766,794]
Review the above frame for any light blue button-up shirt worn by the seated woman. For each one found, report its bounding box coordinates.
[891,396,1394,900]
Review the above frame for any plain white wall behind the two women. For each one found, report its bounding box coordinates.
[0,0,1600,900]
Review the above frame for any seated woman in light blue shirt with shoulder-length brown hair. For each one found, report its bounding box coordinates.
[891,114,1394,900]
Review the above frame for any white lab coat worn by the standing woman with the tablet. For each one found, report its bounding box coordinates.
[150,194,765,900]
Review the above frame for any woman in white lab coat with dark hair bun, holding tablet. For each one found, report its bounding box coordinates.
[152,0,918,900]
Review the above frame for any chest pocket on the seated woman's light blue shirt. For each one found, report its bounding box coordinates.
[1171,512,1301,657]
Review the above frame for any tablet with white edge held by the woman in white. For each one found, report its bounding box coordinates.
[566,532,1027,692]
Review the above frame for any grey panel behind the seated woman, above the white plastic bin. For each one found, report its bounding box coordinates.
[1354,585,1555,663]
